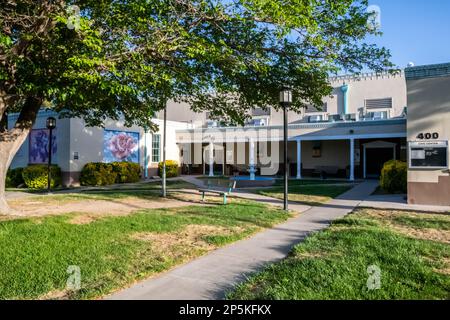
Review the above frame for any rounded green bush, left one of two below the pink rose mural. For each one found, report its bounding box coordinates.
[80,162,117,186]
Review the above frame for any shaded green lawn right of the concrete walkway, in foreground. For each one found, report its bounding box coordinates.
[228,209,450,299]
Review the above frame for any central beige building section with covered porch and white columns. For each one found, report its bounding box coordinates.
[176,72,406,180]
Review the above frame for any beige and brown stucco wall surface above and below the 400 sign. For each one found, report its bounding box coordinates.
[407,66,450,205]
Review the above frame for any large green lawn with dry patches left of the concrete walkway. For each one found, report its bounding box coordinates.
[0,200,289,299]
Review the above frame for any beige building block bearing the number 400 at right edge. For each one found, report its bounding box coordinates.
[406,64,450,205]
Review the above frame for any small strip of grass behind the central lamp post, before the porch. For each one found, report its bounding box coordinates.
[258,184,353,206]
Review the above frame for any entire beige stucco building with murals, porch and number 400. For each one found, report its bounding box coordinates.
[10,64,450,205]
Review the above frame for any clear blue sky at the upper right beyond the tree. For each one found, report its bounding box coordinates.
[370,0,450,68]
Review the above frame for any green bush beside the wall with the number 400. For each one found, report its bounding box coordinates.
[380,160,408,193]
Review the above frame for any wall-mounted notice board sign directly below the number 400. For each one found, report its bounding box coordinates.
[409,141,448,169]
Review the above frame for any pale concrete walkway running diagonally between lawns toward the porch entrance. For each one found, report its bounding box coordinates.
[107,181,378,300]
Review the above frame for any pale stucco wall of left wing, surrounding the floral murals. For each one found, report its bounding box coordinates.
[8,111,190,185]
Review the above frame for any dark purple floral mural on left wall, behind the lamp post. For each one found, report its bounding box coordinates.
[28,129,57,164]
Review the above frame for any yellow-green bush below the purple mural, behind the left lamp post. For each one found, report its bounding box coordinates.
[22,164,61,189]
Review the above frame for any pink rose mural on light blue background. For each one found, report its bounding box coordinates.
[103,130,139,163]
